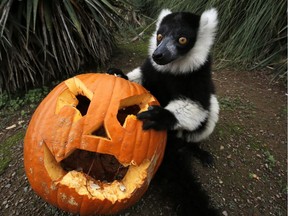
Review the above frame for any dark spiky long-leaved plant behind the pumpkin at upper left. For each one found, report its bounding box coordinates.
[0,0,130,91]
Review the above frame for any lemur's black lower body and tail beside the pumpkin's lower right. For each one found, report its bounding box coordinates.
[152,135,220,216]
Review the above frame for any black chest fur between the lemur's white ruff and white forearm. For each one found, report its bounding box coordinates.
[141,57,215,109]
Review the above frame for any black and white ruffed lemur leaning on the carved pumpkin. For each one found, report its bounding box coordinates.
[108,9,219,215]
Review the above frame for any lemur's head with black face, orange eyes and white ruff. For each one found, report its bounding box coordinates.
[149,9,218,73]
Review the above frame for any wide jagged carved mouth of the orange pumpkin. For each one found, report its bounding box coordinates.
[43,143,151,203]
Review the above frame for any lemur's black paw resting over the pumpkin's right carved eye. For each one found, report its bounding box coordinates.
[137,106,177,130]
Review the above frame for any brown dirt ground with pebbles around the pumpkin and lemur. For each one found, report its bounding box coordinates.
[0,44,287,216]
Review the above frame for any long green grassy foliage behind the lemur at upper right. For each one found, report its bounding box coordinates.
[133,0,287,78]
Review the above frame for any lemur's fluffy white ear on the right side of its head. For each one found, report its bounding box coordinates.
[199,8,218,34]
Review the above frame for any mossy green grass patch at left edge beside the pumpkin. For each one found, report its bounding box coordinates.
[0,130,25,175]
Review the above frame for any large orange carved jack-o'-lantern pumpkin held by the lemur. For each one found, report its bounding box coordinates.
[24,73,166,215]
